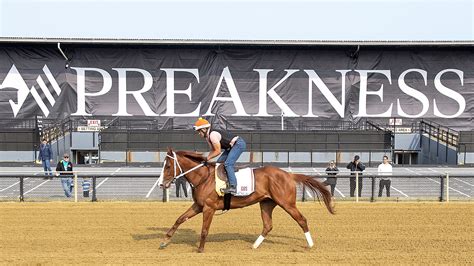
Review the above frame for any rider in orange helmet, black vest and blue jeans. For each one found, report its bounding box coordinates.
[194,118,246,194]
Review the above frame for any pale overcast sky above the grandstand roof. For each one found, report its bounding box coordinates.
[0,0,474,40]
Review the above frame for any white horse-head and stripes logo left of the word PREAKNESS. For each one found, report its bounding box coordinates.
[0,65,61,117]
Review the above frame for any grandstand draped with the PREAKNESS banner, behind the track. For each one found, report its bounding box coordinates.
[0,38,474,202]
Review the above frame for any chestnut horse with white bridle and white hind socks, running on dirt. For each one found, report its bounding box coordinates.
[158,149,334,252]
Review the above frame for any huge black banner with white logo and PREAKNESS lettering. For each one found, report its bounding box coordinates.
[0,44,474,130]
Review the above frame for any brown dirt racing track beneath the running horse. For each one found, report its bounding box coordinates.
[0,202,474,264]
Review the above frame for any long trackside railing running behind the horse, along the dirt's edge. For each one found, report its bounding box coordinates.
[0,171,474,202]
